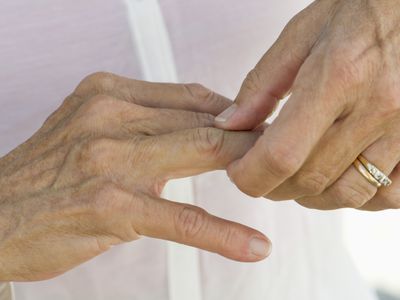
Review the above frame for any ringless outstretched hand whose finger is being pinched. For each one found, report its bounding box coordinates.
[0,73,270,281]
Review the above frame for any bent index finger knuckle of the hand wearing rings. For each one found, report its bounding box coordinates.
[263,144,302,178]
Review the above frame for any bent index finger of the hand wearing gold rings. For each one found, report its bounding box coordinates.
[228,58,343,197]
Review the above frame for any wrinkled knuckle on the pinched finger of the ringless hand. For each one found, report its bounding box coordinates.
[193,127,225,157]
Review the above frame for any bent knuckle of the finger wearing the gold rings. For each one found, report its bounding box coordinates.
[335,182,376,208]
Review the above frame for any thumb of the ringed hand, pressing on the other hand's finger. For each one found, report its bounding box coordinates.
[215,1,325,130]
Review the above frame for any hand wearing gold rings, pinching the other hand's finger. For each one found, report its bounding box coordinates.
[216,0,400,210]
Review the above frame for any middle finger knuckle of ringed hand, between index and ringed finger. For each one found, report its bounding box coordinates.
[293,171,329,196]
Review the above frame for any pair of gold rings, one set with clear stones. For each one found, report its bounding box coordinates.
[353,155,392,188]
